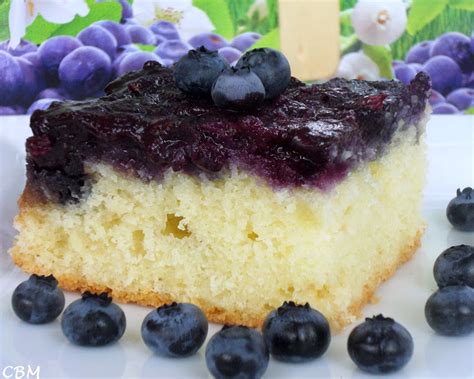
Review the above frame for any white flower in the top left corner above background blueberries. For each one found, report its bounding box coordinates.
[8,0,89,49]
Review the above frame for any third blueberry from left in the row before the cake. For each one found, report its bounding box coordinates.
[142,303,208,357]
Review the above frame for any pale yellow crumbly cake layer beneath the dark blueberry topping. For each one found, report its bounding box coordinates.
[11,121,425,329]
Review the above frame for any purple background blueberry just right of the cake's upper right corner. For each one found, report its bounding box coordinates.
[423,55,463,95]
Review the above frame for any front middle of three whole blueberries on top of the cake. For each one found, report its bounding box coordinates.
[212,67,265,111]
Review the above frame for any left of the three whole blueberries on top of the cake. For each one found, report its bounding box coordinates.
[173,46,230,95]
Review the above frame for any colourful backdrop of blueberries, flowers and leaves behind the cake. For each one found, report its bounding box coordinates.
[0,0,474,115]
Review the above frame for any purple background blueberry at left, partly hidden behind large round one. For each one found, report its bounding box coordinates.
[38,36,82,86]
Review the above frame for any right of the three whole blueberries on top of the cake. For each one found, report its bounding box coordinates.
[236,48,291,99]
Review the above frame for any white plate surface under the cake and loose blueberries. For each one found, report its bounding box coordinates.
[0,116,474,378]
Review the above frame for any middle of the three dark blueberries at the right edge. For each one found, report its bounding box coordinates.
[433,245,474,288]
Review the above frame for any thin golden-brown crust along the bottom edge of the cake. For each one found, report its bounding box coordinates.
[11,230,423,331]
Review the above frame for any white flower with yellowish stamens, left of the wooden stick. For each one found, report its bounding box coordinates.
[132,0,214,41]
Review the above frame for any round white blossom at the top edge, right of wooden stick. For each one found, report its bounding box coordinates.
[352,0,407,45]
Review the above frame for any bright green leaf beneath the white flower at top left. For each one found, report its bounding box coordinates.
[24,0,122,44]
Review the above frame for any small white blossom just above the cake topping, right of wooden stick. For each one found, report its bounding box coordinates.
[337,51,380,80]
